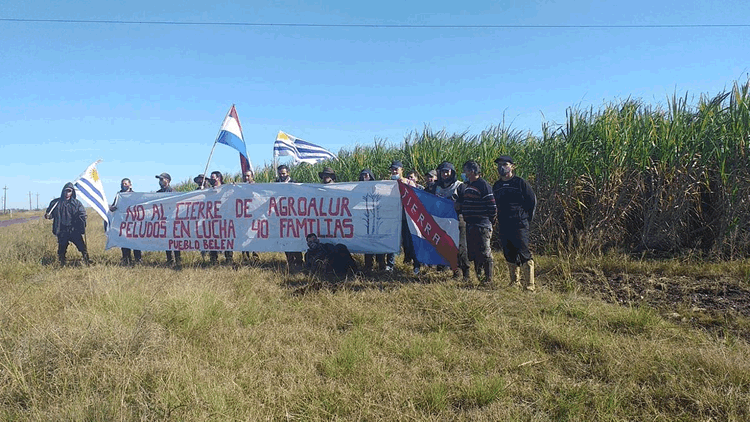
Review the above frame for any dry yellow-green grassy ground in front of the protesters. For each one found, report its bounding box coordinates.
[0,216,750,421]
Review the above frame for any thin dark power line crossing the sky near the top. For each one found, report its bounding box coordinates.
[0,18,750,29]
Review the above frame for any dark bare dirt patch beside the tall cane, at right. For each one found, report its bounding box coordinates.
[553,269,750,341]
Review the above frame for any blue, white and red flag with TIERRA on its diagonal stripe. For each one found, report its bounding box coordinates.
[398,183,458,269]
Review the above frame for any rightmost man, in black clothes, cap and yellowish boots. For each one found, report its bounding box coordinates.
[492,155,536,291]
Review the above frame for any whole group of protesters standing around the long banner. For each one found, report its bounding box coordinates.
[45,155,536,291]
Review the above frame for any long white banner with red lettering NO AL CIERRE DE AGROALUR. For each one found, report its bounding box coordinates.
[107,180,401,253]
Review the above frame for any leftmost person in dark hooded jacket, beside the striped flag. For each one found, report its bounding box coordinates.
[44,182,90,266]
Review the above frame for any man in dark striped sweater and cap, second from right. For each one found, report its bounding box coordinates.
[458,160,497,285]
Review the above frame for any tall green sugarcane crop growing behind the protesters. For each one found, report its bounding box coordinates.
[197,78,750,259]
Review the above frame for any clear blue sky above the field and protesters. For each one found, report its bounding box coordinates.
[0,0,750,208]
